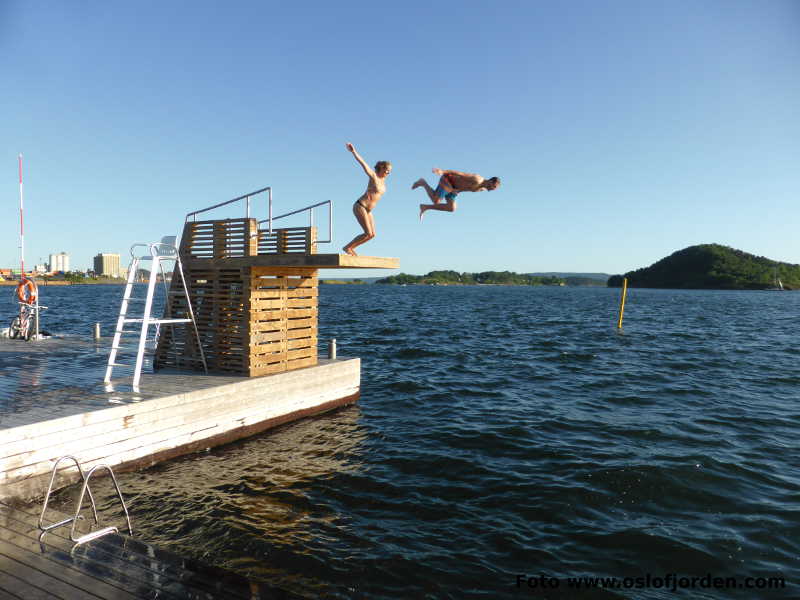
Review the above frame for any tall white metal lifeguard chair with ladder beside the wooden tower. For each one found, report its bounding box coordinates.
[103,236,208,392]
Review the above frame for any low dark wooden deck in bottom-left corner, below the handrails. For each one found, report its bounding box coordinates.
[0,503,296,600]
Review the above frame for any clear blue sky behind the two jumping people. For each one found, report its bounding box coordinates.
[0,0,800,276]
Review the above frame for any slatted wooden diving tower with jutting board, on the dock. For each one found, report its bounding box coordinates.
[154,218,399,377]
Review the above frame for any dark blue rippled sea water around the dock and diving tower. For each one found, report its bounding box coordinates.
[17,285,800,598]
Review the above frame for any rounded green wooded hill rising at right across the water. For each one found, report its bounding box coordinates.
[608,244,800,290]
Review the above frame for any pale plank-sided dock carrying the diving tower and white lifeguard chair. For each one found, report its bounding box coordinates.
[0,339,361,501]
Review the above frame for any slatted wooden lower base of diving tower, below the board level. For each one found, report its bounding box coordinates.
[155,267,319,377]
